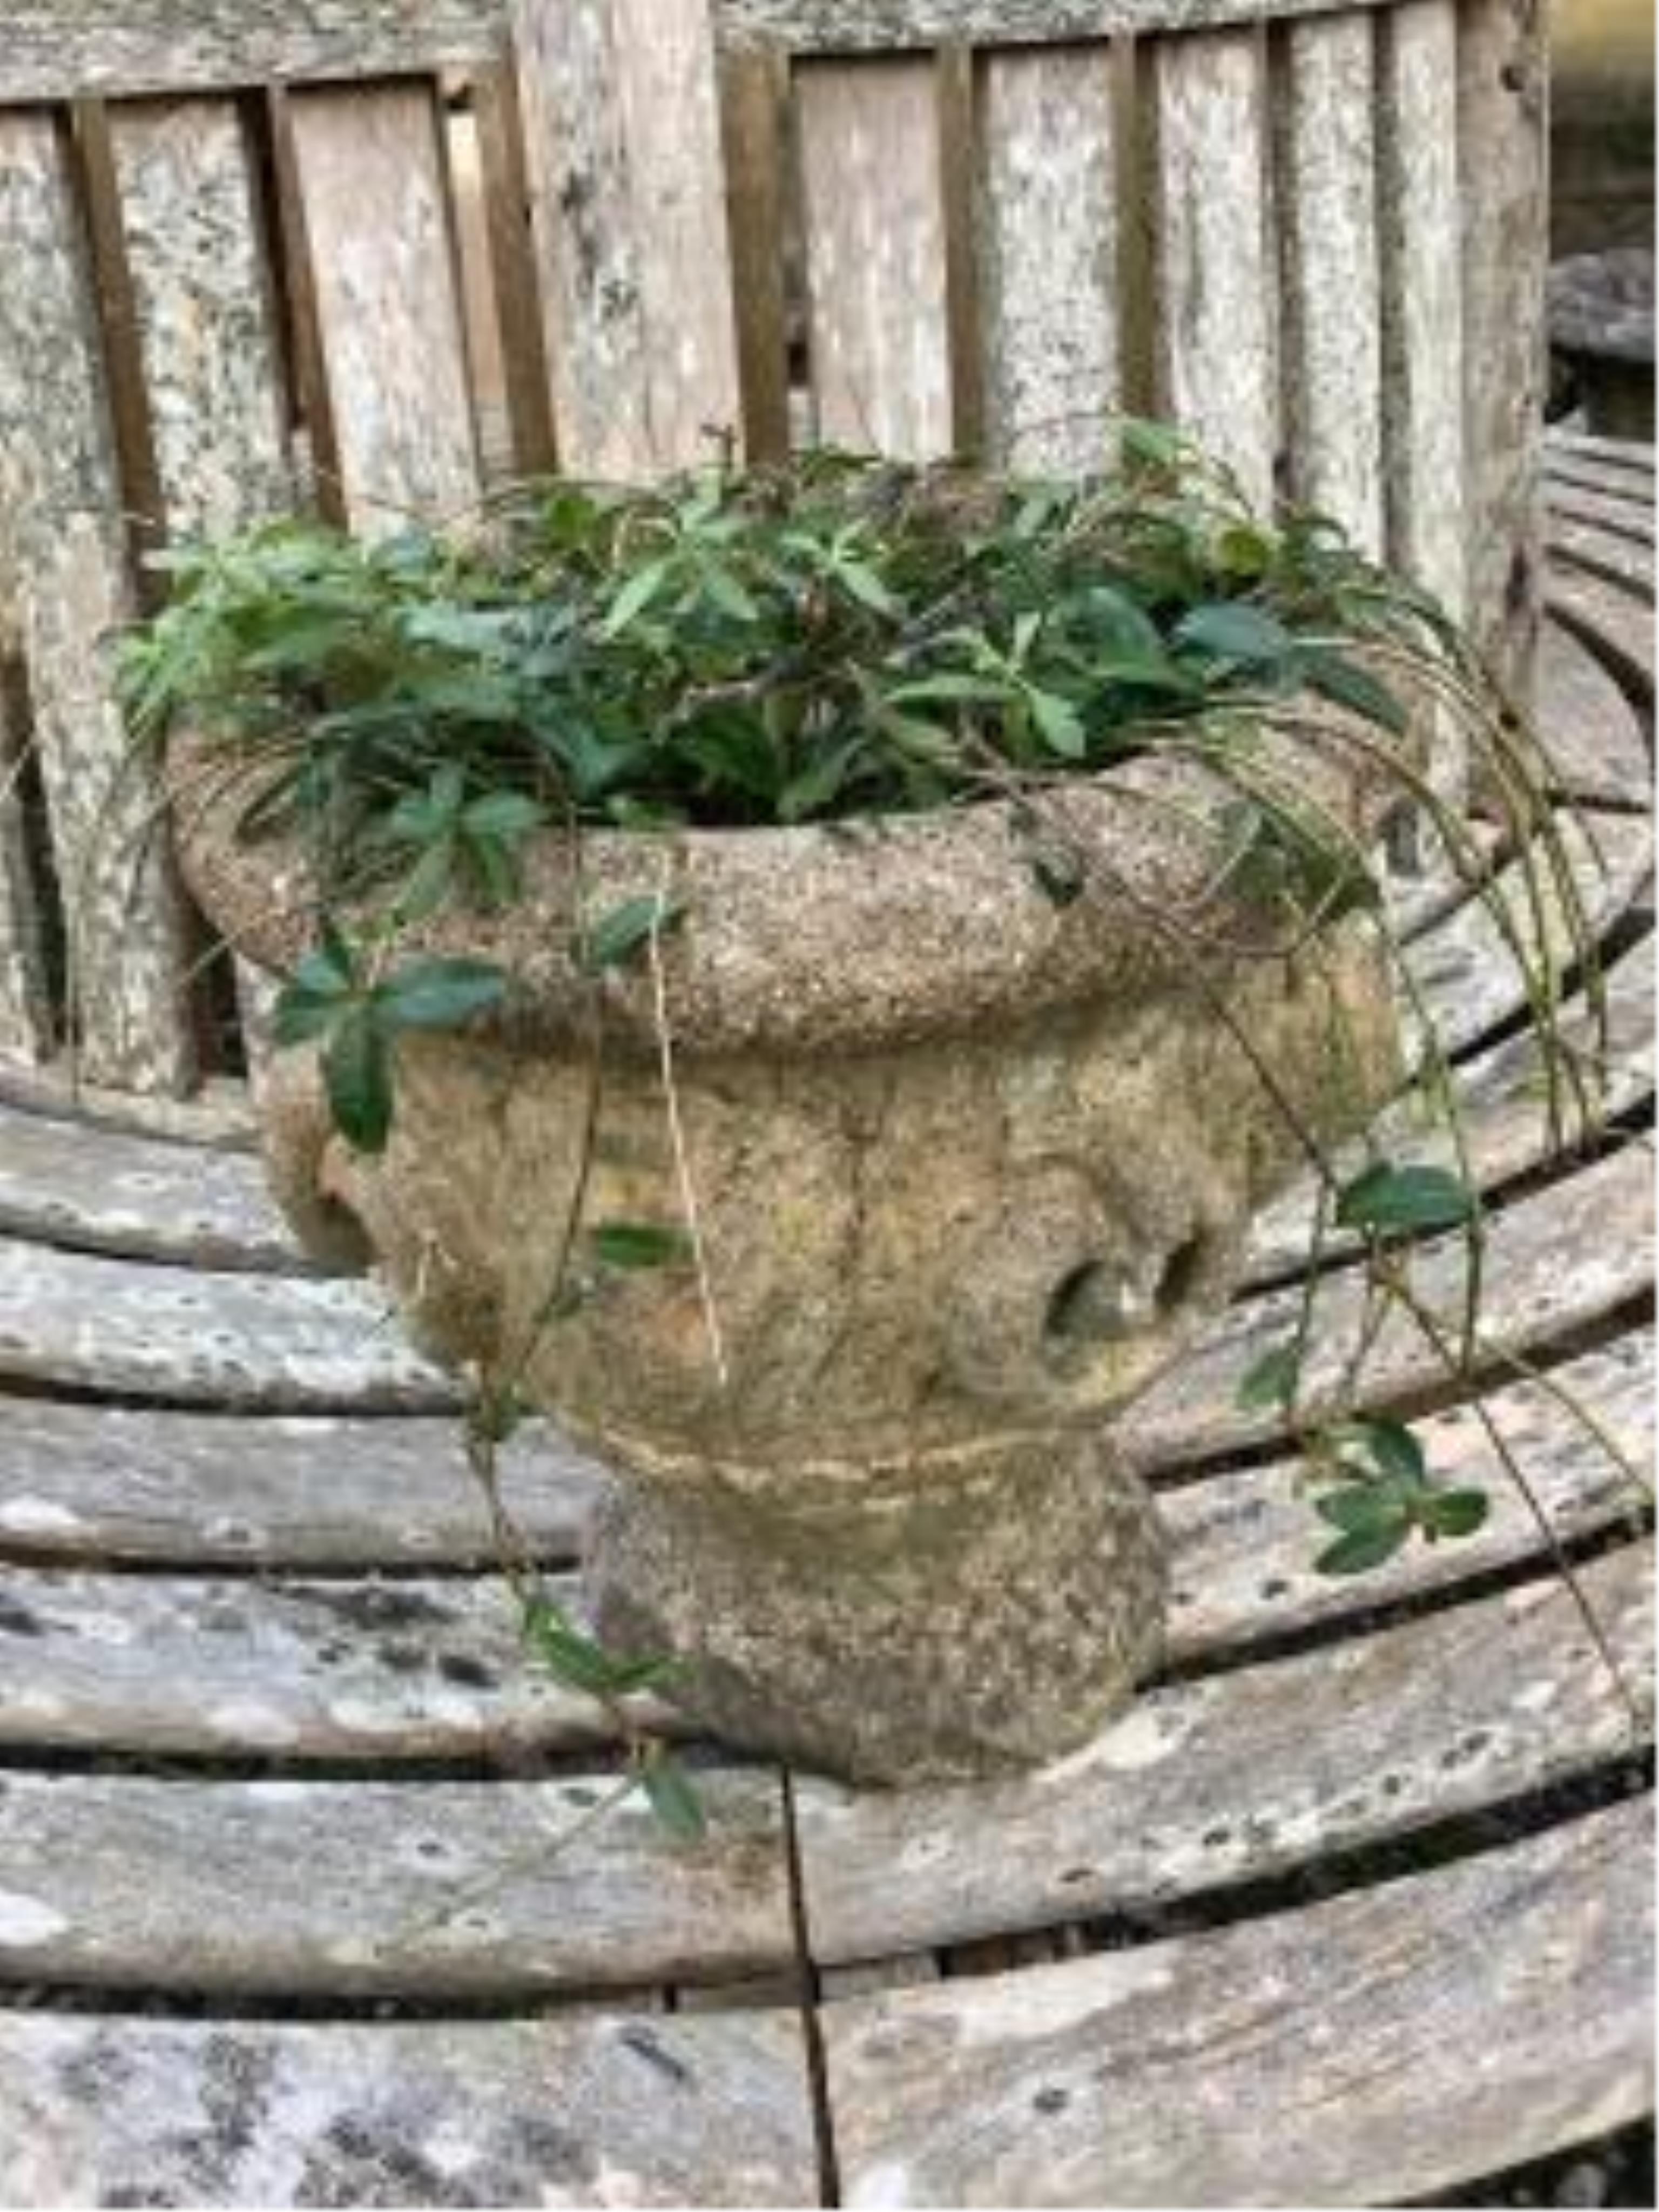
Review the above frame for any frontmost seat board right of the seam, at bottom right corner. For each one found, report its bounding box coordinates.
[823,1803,1653,2208]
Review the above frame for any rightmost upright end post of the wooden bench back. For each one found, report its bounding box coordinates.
[1458,0,1548,699]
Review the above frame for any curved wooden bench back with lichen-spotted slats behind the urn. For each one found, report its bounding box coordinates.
[0,0,1544,1095]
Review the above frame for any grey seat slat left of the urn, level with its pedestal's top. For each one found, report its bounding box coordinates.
[0,1398,602,1570]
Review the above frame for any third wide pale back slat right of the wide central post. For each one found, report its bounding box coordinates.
[1146,31,1278,502]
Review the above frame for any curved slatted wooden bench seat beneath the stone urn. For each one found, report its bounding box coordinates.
[0,462,1653,2206]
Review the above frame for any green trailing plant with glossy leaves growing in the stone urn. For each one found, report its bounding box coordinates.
[126,424,1637,1796]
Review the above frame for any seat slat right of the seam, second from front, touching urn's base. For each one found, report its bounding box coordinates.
[794,1546,1653,1960]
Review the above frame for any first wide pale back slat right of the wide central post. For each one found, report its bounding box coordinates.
[797,60,953,460]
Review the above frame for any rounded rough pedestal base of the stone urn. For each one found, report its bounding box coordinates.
[589,1433,1166,1783]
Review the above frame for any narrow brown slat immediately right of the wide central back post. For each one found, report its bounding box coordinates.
[721,53,790,460]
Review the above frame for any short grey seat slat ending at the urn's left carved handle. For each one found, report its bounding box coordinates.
[0,1102,298,1274]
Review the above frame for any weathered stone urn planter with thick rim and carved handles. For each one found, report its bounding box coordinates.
[186,739,1396,1783]
